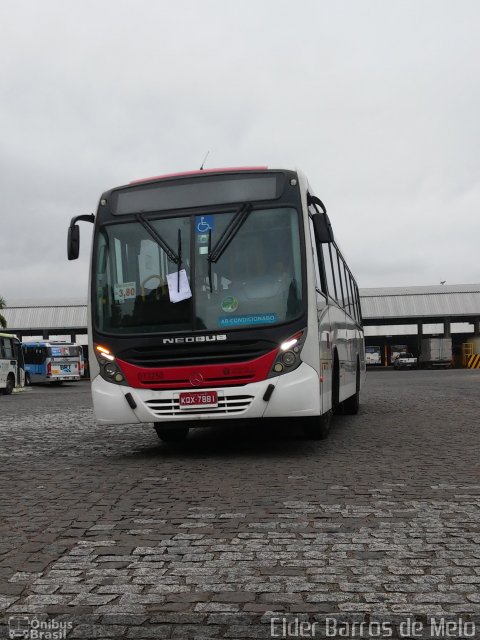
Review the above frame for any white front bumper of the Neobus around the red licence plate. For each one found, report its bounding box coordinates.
[92,362,321,427]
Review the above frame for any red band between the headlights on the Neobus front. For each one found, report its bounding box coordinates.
[115,349,278,389]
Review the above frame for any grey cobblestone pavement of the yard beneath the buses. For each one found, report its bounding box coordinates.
[0,370,480,640]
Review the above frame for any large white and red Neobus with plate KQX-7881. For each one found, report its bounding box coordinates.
[68,167,365,440]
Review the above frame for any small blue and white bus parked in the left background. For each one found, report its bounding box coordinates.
[23,340,84,385]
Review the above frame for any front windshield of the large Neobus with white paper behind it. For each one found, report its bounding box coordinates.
[93,207,303,334]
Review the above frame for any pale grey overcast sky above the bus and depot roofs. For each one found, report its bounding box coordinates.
[0,0,480,303]
